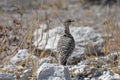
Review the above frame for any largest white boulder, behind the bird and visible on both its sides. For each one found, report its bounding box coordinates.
[33,27,104,64]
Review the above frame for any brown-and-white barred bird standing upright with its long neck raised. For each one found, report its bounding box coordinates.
[57,19,75,65]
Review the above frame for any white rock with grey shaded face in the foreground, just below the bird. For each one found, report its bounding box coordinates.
[37,63,71,80]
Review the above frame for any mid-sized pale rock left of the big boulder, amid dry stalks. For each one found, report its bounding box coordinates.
[10,49,29,64]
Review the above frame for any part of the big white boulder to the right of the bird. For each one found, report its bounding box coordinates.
[71,27,104,53]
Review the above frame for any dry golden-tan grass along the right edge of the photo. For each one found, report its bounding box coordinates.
[104,19,120,74]
